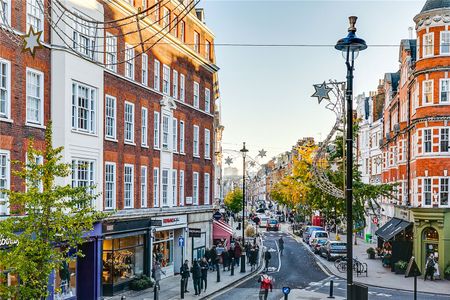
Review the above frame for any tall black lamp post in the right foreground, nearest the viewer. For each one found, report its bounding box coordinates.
[334,16,367,300]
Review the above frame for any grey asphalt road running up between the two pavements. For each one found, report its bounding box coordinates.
[214,232,449,300]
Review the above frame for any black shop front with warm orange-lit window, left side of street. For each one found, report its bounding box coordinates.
[101,219,150,296]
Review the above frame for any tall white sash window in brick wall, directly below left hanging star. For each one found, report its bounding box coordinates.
[27,68,44,125]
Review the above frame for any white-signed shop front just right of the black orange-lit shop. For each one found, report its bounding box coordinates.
[151,215,187,277]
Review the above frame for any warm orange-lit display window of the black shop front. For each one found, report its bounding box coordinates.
[102,235,144,284]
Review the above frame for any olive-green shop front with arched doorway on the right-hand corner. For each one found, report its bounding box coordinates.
[411,208,450,274]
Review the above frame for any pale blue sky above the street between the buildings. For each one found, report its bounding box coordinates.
[199,0,425,166]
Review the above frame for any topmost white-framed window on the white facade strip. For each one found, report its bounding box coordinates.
[73,17,97,59]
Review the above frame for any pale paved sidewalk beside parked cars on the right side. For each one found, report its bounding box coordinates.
[290,233,450,295]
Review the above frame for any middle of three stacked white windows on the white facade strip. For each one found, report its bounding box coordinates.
[72,82,97,134]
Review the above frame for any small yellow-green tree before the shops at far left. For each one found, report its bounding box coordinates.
[0,124,105,299]
